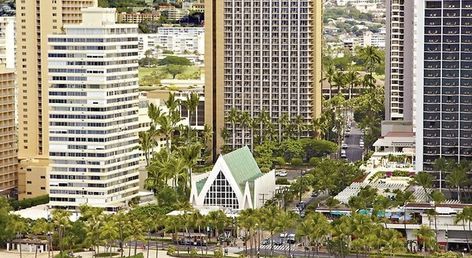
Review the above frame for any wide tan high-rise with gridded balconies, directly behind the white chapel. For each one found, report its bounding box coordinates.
[205,0,323,155]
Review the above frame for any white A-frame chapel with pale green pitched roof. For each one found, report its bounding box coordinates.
[190,146,275,210]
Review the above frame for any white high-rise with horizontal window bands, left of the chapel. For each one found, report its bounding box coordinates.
[48,8,140,210]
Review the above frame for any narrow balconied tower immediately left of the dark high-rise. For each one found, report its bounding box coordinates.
[385,0,415,121]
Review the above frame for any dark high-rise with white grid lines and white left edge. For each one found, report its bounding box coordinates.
[415,0,472,182]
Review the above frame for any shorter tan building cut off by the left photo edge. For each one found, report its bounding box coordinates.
[0,67,18,195]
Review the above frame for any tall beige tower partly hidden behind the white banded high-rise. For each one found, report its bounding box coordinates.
[16,0,97,199]
